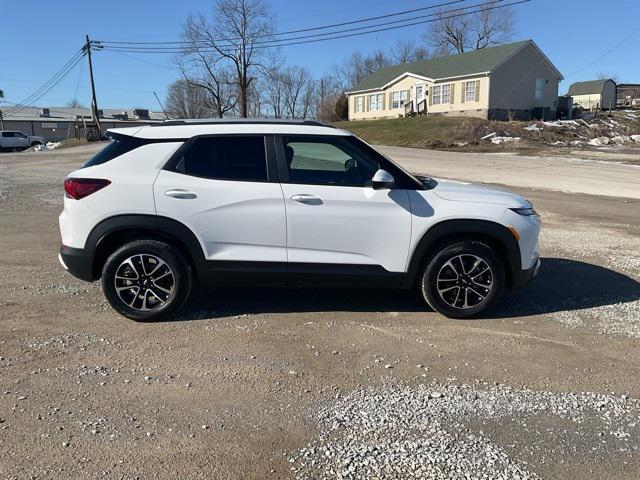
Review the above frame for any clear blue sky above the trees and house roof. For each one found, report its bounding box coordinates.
[0,0,640,110]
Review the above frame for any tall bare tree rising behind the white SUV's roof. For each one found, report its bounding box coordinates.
[183,0,274,117]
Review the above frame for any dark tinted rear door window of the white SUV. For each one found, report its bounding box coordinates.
[177,136,267,182]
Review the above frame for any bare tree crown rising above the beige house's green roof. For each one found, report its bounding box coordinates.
[425,0,514,56]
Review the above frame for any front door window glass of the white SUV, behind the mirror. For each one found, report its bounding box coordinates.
[283,137,379,187]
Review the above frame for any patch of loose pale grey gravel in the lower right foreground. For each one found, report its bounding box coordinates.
[289,383,640,479]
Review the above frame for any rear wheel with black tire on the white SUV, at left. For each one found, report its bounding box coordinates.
[102,240,193,322]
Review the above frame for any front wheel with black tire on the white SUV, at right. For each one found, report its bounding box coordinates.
[419,240,505,318]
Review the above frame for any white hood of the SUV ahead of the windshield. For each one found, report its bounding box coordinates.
[433,180,531,207]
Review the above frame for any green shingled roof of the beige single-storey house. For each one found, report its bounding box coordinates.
[350,40,537,92]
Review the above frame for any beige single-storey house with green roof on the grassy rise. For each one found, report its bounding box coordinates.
[345,40,563,120]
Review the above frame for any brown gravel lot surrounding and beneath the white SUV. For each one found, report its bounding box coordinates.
[0,145,640,480]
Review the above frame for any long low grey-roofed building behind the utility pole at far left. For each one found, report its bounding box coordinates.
[0,105,165,141]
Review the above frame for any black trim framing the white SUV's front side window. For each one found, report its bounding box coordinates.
[274,133,424,190]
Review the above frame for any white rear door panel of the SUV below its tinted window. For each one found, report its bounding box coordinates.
[154,170,287,263]
